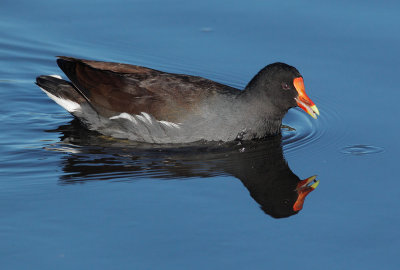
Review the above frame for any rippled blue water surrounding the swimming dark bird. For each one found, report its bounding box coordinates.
[0,0,400,269]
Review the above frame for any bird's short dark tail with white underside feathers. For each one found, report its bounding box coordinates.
[36,75,87,115]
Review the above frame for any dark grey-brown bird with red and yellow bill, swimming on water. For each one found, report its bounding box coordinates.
[36,56,320,144]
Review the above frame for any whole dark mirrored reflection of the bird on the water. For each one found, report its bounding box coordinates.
[48,120,319,218]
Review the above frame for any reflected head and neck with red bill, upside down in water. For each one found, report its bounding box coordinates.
[214,137,318,218]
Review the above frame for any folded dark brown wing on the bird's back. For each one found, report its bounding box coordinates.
[57,56,240,121]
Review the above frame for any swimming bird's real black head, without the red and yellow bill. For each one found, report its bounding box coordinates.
[245,63,302,116]
